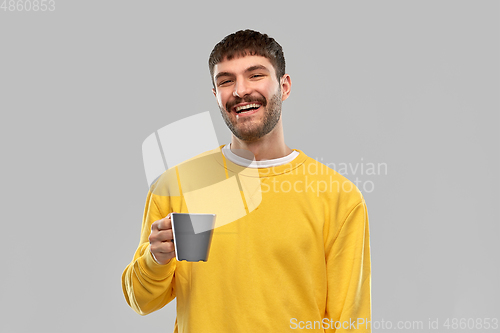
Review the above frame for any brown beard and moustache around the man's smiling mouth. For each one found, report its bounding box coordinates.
[219,88,282,142]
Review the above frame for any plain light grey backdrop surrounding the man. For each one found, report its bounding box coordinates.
[0,0,500,333]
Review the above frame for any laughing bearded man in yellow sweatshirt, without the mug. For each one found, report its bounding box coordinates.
[122,30,371,333]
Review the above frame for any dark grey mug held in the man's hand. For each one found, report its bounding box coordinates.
[171,213,215,262]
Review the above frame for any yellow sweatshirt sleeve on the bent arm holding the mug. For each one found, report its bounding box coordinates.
[122,191,176,315]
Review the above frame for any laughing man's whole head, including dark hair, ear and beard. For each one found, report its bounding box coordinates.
[209,30,291,142]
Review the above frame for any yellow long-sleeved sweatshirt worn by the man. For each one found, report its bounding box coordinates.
[122,146,371,333]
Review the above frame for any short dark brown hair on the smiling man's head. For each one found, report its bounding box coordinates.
[208,29,285,88]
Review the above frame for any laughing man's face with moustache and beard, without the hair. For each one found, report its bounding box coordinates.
[212,56,290,142]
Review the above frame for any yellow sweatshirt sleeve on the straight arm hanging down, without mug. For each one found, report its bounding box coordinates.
[325,200,371,333]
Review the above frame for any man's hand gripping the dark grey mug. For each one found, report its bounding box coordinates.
[149,214,175,265]
